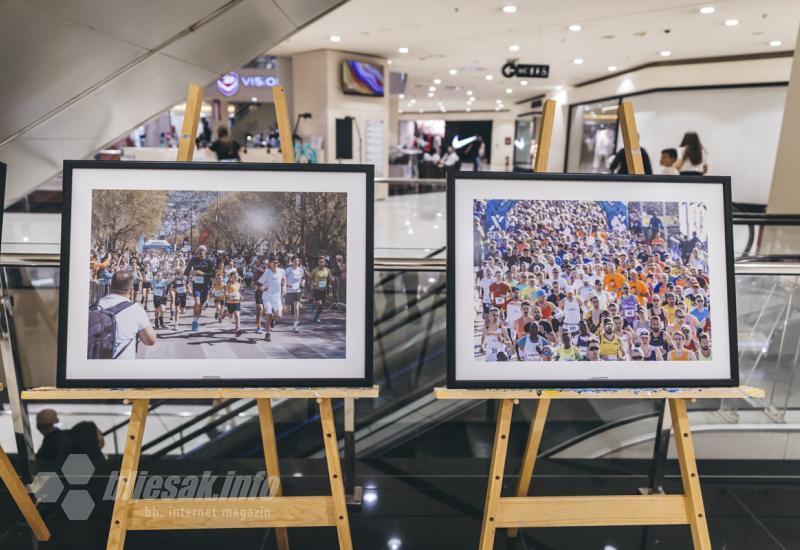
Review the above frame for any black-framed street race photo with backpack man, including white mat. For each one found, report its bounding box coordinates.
[58,161,374,387]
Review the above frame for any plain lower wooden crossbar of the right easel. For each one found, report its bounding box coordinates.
[495,495,690,528]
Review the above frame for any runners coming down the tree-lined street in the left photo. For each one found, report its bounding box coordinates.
[90,245,347,341]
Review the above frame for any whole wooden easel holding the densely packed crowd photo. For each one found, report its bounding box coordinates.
[444,99,764,550]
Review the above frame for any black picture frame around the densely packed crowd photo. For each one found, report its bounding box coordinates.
[446,172,739,389]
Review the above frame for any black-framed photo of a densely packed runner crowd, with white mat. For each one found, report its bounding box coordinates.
[447,172,739,388]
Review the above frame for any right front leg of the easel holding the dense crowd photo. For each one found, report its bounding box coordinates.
[669,399,711,550]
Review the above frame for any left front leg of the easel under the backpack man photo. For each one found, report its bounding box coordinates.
[106,399,150,550]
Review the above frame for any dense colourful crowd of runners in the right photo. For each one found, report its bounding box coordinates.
[474,201,711,361]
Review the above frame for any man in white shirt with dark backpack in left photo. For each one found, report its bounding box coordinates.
[87,271,156,359]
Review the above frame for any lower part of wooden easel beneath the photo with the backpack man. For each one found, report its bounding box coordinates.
[22,386,378,550]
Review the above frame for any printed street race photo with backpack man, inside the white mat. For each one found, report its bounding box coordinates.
[83,189,348,360]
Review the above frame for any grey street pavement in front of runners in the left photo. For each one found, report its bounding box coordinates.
[136,289,345,359]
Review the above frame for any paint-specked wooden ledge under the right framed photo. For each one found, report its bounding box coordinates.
[434,386,766,399]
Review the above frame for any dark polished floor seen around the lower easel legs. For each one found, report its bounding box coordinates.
[0,459,800,550]
